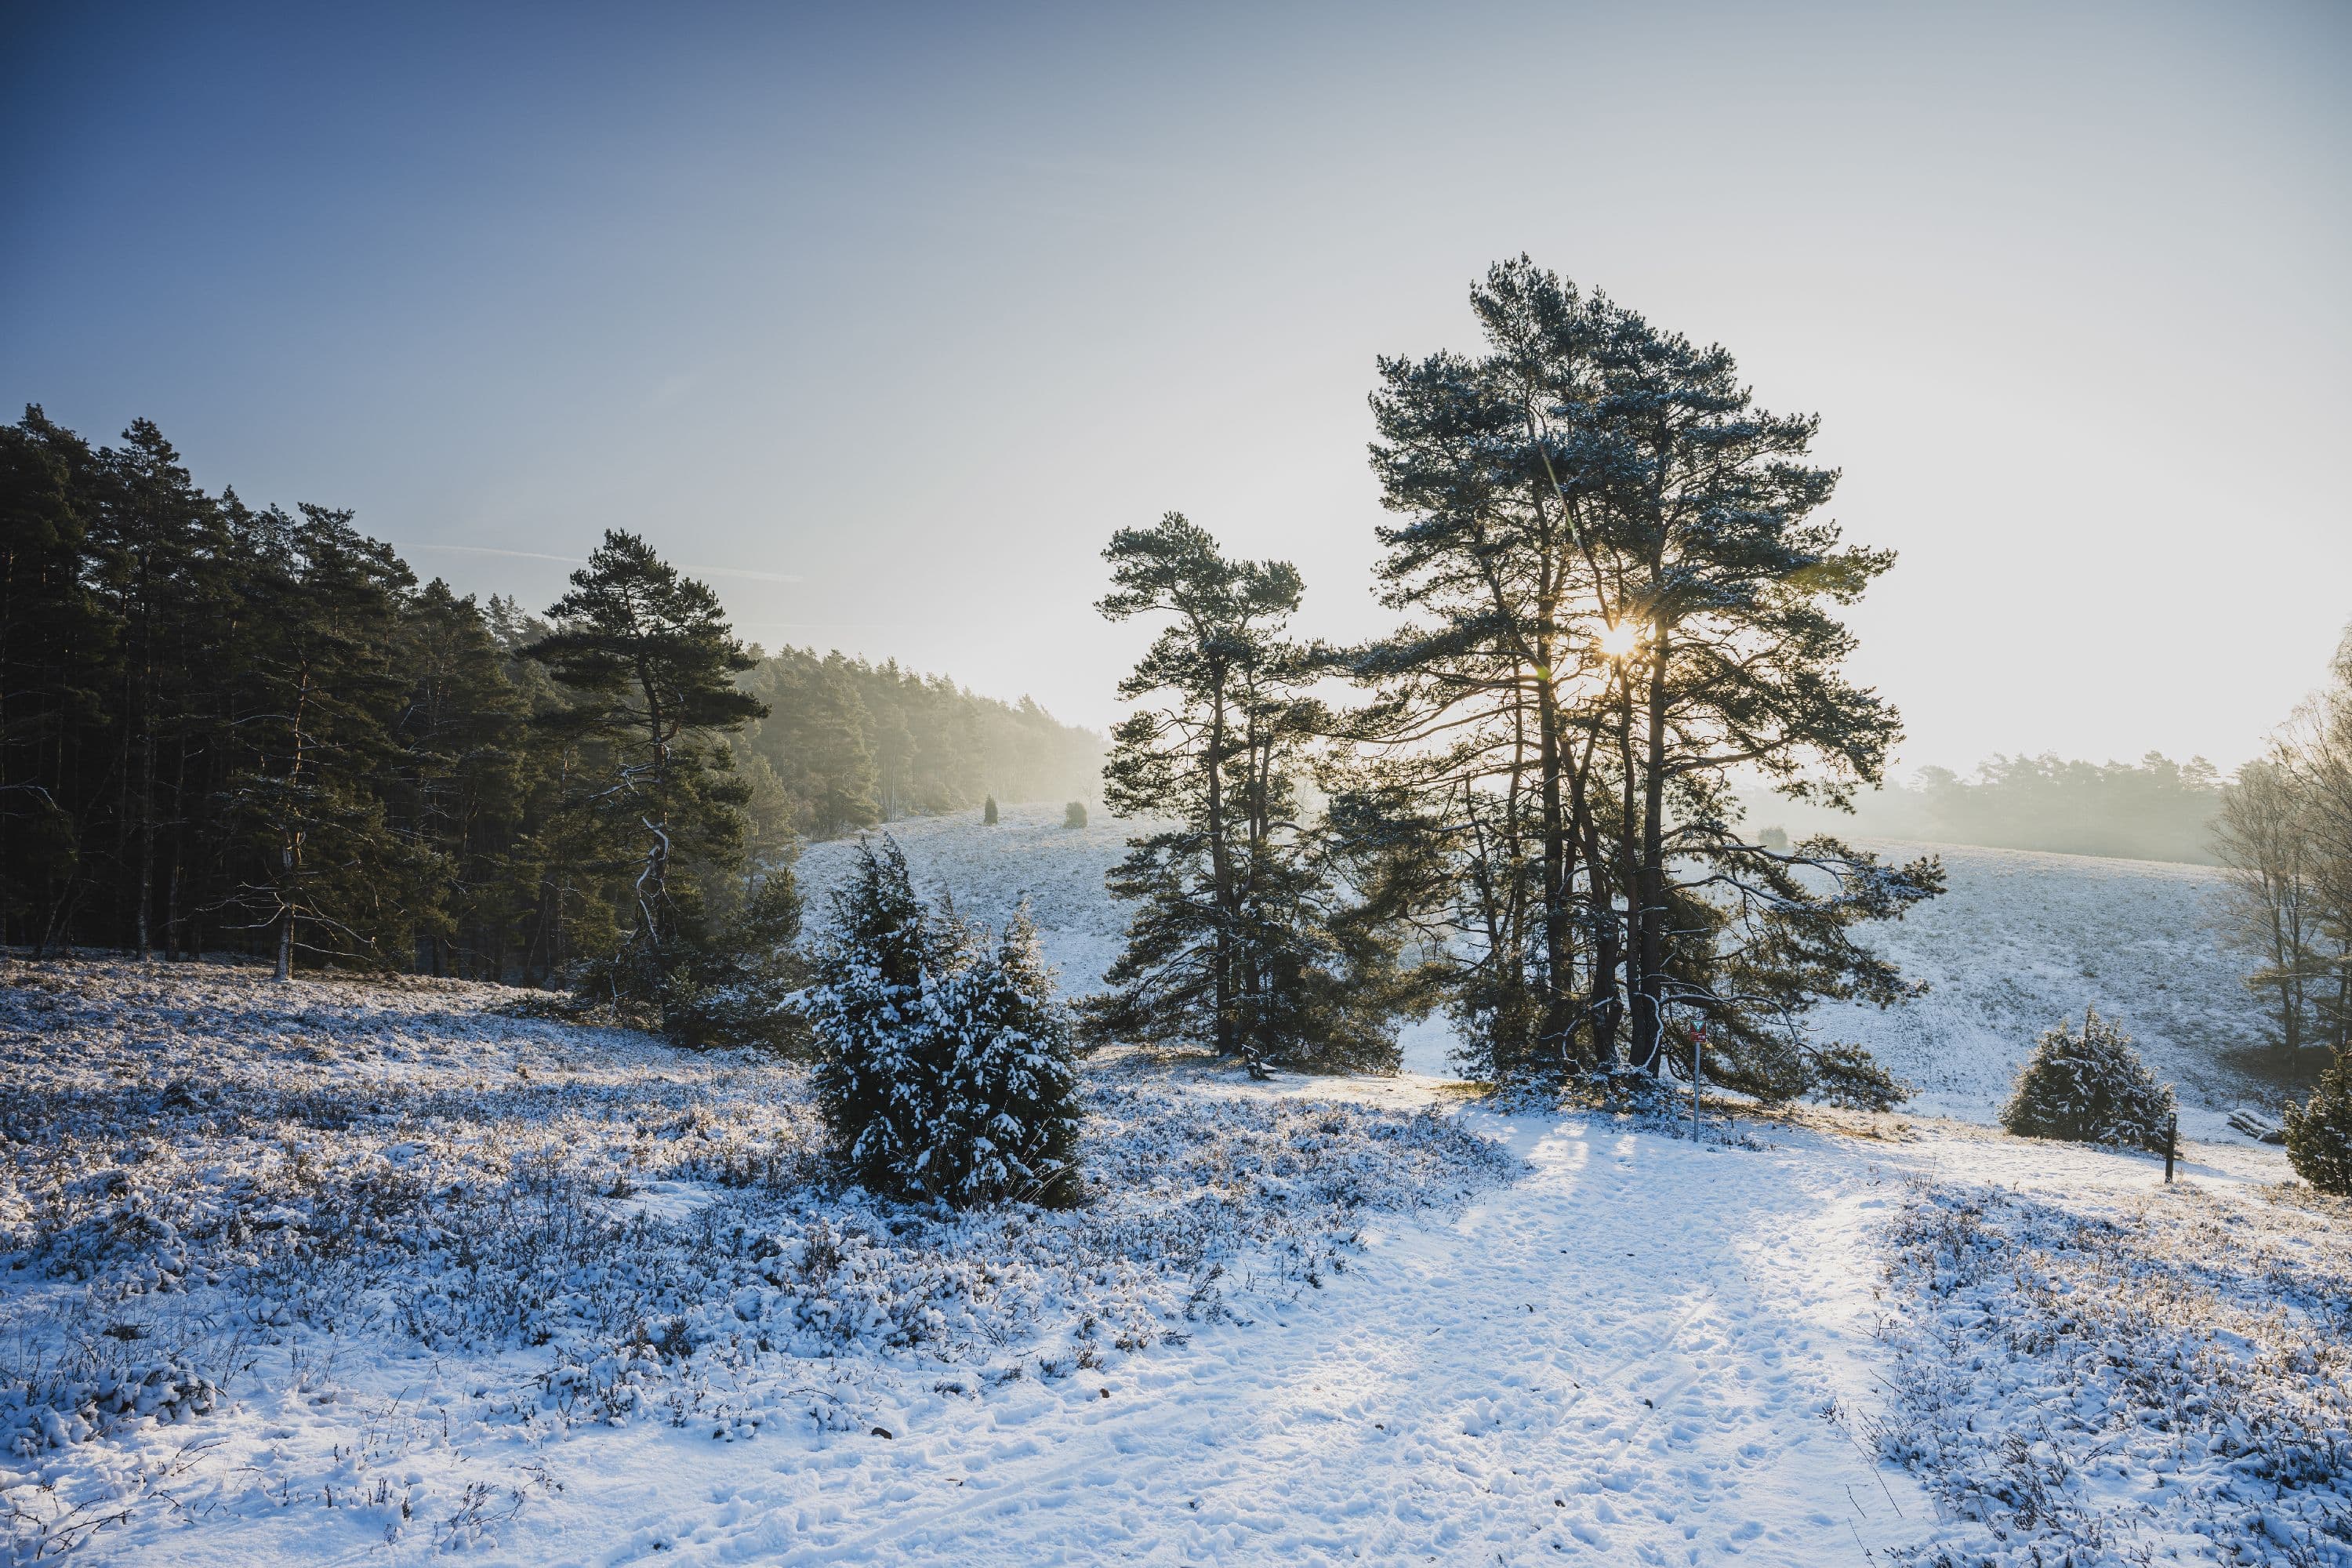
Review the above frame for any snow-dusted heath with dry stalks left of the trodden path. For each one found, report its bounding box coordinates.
[0,961,1512,1559]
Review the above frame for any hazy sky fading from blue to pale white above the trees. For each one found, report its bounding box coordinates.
[0,5,2352,769]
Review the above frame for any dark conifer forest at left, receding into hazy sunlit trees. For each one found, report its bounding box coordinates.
[0,409,1103,982]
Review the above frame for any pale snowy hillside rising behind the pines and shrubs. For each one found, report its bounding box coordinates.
[802,806,2265,1135]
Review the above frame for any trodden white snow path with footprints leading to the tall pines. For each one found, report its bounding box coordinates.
[517,1116,1926,1563]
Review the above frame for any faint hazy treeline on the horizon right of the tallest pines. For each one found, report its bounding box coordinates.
[1740,753,2223,865]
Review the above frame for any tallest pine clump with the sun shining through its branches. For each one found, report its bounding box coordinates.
[1355,256,1940,1091]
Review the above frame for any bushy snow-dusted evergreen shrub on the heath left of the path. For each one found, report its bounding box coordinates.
[809,834,1077,1206]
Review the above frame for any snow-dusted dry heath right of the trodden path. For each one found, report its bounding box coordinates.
[1872,1156,2352,1566]
